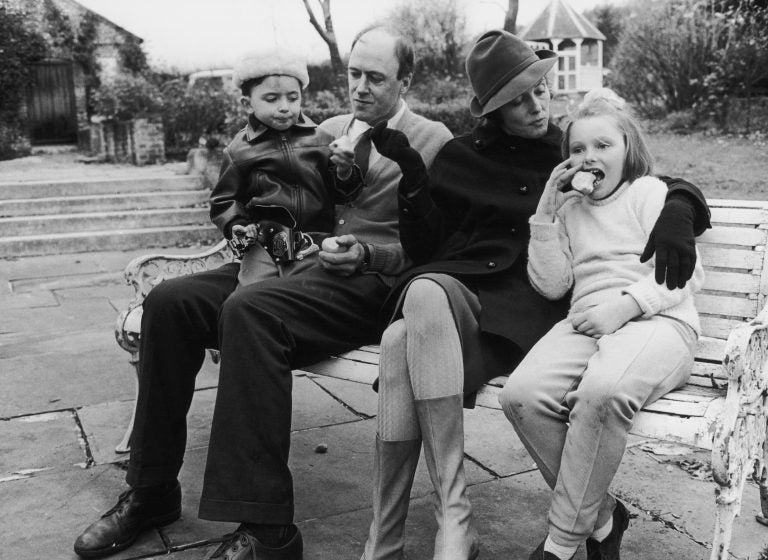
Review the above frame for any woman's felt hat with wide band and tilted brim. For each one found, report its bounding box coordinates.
[466,29,557,117]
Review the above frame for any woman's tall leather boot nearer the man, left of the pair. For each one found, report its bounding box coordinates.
[362,434,421,560]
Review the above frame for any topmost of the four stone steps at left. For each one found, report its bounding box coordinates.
[0,175,201,200]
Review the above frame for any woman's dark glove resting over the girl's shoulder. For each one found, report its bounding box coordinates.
[640,194,696,290]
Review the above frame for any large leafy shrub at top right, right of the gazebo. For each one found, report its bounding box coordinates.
[609,0,768,130]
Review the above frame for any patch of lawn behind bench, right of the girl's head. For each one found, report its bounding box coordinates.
[646,132,768,201]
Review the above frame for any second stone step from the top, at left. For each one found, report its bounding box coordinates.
[0,190,209,218]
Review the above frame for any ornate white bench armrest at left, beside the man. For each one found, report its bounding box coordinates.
[115,240,235,355]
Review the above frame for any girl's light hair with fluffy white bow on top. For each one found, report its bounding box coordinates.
[561,88,653,182]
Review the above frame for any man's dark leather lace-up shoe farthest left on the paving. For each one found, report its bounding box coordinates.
[75,481,181,558]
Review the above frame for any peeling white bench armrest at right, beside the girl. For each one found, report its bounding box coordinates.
[712,300,768,487]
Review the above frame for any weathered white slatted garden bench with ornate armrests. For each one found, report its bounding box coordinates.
[116,200,768,560]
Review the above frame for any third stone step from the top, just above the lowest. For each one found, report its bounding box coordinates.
[0,208,211,238]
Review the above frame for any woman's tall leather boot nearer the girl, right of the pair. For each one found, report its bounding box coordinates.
[415,395,480,560]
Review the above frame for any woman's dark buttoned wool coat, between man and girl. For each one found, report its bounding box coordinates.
[385,122,568,393]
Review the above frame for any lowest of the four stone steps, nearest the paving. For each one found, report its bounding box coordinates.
[0,224,221,258]
